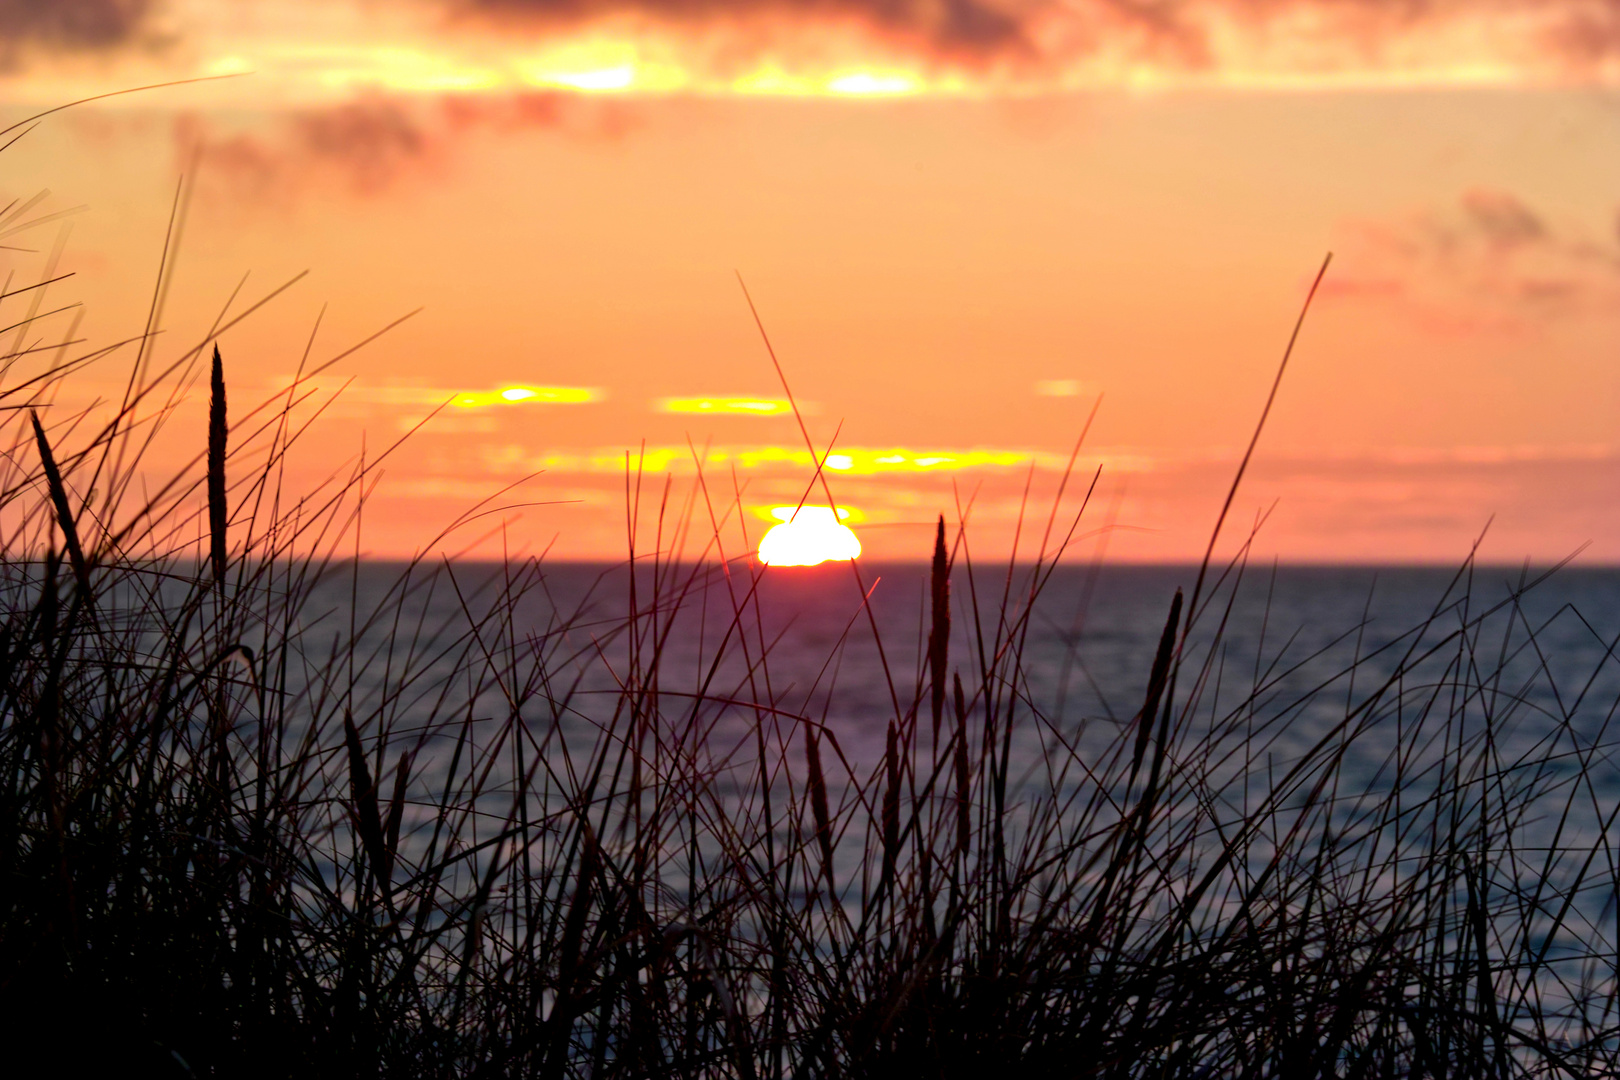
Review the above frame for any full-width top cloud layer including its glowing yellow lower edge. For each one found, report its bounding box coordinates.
[12,0,1620,94]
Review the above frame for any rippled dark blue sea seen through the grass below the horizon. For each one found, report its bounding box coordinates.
[34,560,1620,1052]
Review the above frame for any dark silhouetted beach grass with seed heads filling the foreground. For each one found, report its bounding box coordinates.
[0,196,1620,1078]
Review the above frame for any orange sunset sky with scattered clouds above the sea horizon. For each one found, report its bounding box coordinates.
[0,0,1620,563]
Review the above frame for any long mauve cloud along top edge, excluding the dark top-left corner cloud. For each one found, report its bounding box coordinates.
[437,0,1620,86]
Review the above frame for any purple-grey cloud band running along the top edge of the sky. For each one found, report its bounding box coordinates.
[15,0,1620,89]
